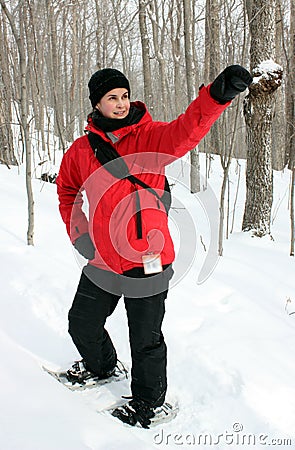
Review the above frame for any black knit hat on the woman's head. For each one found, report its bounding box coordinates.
[88,69,130,108]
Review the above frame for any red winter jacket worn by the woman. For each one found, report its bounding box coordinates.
[57,86,229,273]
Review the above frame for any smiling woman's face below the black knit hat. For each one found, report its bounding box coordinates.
[96,88,130,119]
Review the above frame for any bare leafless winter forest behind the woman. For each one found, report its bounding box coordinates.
[0,0,295,255]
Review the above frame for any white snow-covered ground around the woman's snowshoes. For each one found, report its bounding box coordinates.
[0,157,295,450]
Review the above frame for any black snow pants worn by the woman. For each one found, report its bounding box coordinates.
[69,266,173,406]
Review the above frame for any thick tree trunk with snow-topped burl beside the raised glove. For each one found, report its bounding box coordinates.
[242,0,282,236]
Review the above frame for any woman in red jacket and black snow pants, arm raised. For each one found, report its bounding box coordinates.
[57,65,252,427]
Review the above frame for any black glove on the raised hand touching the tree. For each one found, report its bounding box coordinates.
[210,65,253,105]
